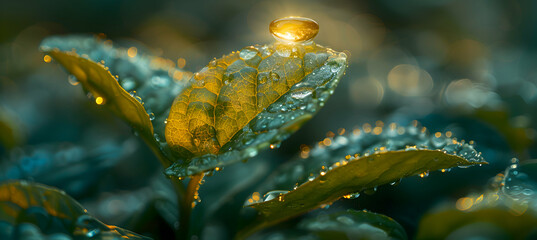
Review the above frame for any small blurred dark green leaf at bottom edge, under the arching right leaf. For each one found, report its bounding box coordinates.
[298,210,407,240]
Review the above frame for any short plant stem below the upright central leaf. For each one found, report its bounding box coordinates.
[178,173,205,239]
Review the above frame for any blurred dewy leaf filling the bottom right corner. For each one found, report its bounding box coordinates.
[417,160,537,239]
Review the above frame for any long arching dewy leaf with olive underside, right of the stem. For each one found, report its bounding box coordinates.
[241,123,486,236]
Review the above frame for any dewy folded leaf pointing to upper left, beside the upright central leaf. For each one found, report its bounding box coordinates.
[41,36,191,166]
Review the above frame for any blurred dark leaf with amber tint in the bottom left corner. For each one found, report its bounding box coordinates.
[0,181,149,240]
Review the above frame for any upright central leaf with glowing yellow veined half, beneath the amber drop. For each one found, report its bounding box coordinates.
[166,43,346,177]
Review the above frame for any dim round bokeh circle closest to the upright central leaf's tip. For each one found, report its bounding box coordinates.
[349,78,384,108]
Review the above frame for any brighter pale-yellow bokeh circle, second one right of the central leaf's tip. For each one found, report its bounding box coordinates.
[388,64,433,96]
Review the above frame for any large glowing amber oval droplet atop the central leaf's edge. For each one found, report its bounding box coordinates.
[269,17,319,43]
